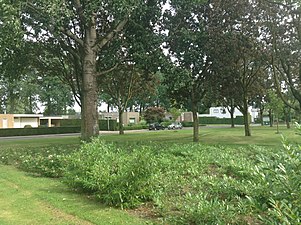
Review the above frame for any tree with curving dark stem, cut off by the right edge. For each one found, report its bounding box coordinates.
[260,0,301,112]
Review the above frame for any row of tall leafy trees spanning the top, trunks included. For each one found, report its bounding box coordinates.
[0,0,301,141]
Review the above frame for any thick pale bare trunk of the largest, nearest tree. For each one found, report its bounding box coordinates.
[81,22,99,141]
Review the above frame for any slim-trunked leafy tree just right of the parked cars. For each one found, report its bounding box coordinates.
[165,0,211,142]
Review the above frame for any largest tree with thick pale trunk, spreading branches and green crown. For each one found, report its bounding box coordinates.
[11,0,161,140]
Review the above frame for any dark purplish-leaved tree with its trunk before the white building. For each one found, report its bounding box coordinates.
[208,0,267,136]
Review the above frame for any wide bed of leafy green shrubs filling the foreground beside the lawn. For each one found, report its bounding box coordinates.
[0,124,301,224]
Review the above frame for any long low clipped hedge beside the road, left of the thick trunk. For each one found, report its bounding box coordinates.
[0,127,80,137]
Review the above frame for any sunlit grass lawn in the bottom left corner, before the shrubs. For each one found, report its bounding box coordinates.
[0,165,144,225]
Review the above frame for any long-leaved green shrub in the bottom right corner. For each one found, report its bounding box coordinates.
[246,126,301,224]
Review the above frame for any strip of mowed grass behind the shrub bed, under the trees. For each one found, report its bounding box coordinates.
[102,126,301,146]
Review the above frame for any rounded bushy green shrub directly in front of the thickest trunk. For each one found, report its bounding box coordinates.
[65,139,156,207]
